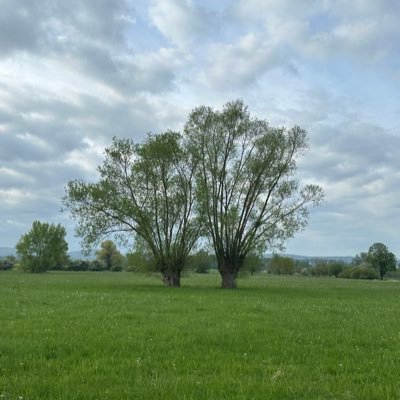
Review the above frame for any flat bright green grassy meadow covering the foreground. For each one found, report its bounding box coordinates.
[0,272,400,400]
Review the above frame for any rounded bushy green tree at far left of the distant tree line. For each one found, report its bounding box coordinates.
[16,221,68,272]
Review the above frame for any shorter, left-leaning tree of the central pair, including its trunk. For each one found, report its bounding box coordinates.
[63,131,201,286]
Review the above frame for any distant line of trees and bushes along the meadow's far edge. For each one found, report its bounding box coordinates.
[7,221,400,279]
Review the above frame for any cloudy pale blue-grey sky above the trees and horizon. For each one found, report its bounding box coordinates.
[0,0,400,256]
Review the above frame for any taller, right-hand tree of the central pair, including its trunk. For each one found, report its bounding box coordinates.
[185,100,323,288]
